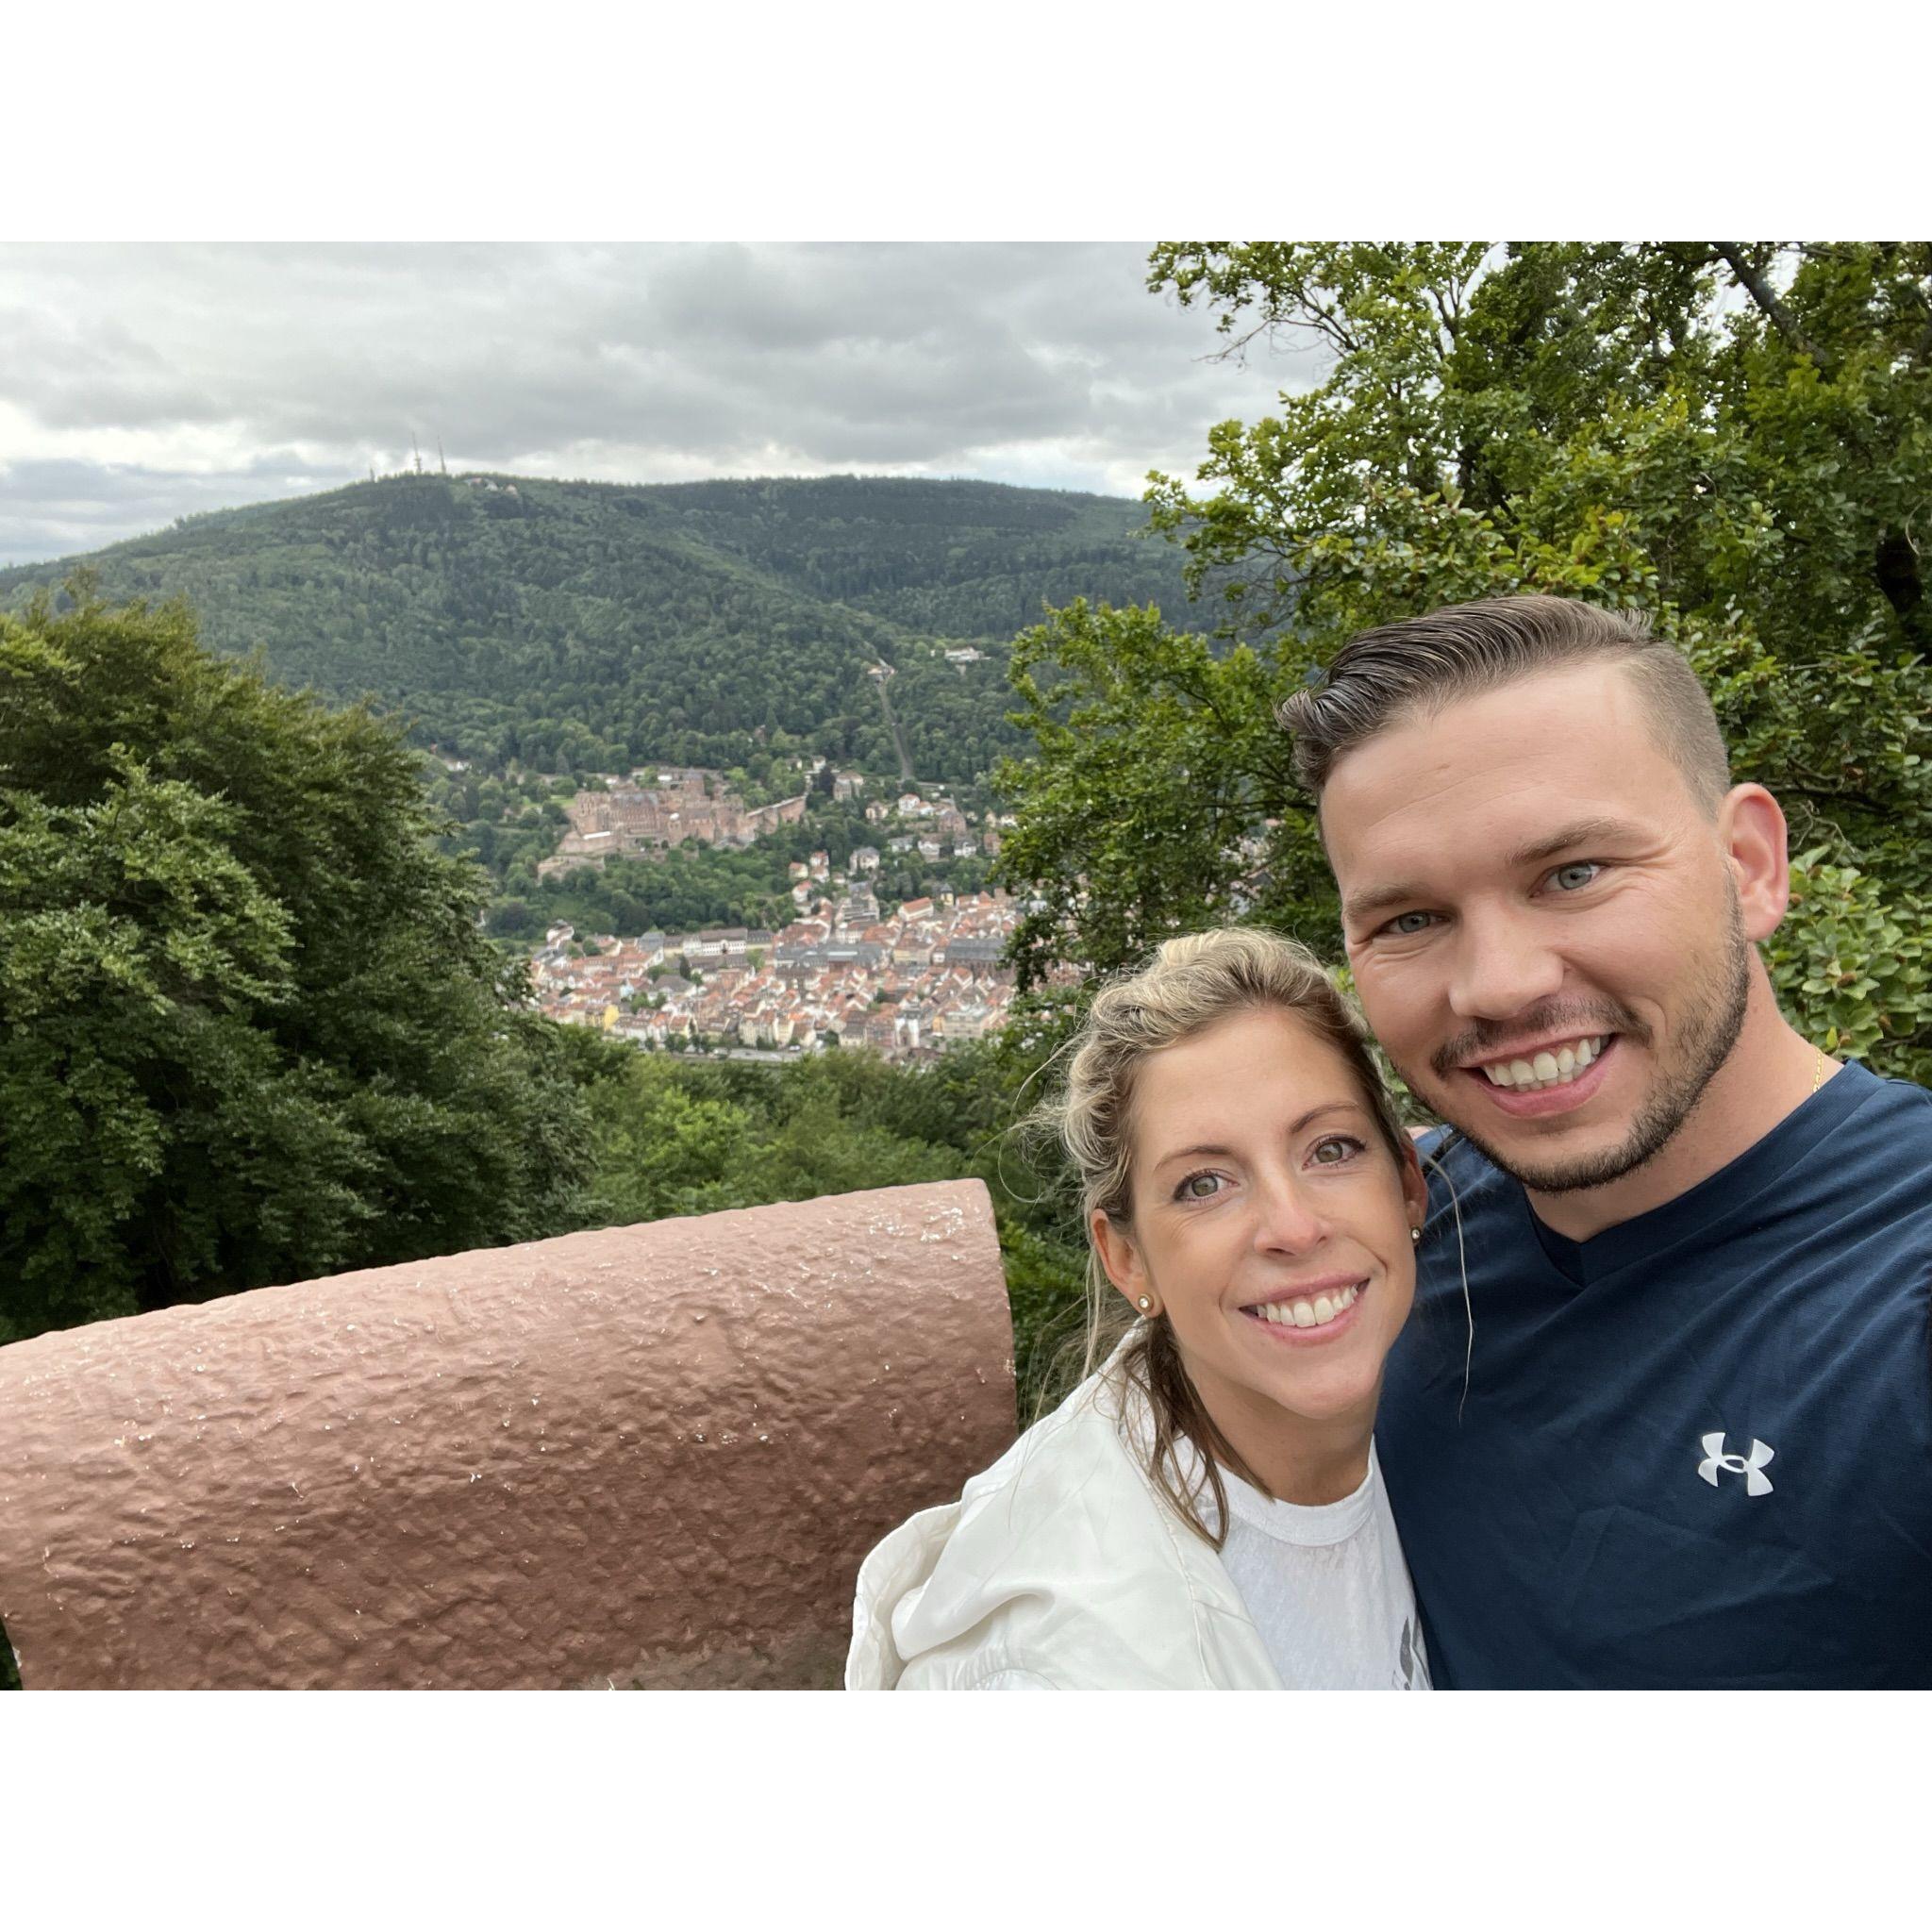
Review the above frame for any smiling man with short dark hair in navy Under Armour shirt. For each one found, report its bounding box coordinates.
[1283,597,1932,1689]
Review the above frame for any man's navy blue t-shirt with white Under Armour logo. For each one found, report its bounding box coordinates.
[1375,1064,1932,1689]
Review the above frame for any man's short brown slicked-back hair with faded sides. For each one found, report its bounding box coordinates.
[1277,597,1731,817]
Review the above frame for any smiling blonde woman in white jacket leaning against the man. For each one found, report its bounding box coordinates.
[846,927,1427,1690]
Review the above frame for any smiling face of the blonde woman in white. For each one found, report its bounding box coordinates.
[1093,1007,1427,1445]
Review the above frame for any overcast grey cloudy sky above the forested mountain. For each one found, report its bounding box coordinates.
[0,242,1314,562]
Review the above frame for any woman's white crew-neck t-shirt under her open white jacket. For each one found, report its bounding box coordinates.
[1202,1443,1430,1690]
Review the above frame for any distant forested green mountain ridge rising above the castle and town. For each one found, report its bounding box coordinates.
[0,472,1184,780]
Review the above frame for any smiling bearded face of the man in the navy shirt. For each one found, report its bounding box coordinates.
[1322,665,1750,1194]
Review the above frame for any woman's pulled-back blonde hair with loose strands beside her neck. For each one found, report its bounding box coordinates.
[1036,925,1410,1547]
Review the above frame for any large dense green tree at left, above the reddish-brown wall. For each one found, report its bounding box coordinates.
[0,581,590,1341]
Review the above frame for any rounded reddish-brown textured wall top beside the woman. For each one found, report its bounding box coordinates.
[0,1180,1014,1690]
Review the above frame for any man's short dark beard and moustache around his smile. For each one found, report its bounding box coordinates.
[1397,891,1750,1194]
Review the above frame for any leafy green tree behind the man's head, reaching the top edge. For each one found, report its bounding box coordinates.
[999,242,1932,1080]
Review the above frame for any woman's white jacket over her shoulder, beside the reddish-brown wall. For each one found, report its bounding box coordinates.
[846,1368,1281,1690]
